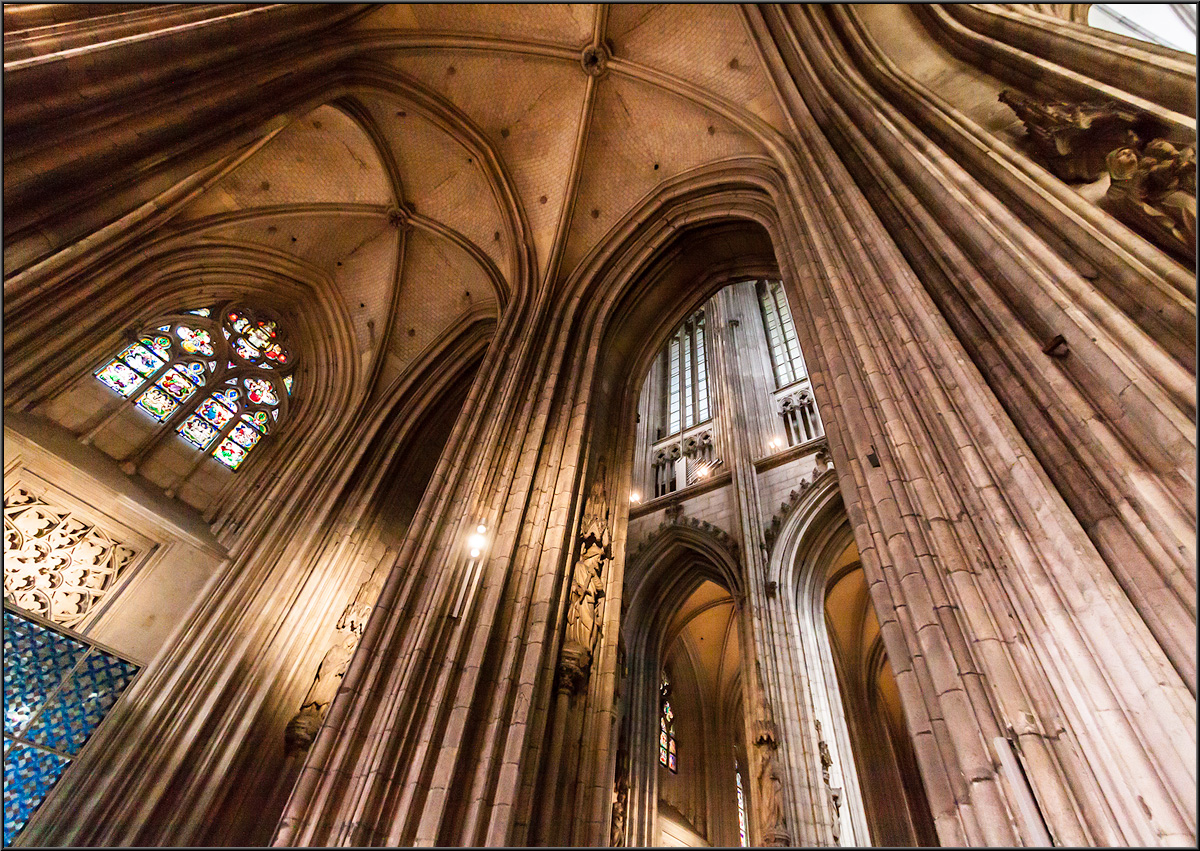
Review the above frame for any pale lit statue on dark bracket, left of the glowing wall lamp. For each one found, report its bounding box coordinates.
[283,553,391,753]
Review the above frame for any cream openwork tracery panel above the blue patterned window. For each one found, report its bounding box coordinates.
[4,487,137,627]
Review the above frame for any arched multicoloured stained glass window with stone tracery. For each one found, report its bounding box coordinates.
[95,304,295,469]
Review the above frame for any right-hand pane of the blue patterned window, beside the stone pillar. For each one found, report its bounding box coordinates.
[25,648,138,754]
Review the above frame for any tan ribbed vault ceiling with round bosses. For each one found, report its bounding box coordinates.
[166,5,782,408]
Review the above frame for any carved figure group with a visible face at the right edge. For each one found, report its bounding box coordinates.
[1105,139,1196,258]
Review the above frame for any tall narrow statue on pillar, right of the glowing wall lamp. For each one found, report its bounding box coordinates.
[563,462,612,671]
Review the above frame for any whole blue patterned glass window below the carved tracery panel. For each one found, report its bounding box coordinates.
[4,605,138,847]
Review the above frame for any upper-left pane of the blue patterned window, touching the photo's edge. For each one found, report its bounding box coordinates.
[4,611,88,735]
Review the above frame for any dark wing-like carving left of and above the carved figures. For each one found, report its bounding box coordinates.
[1000,89,1160,182]
